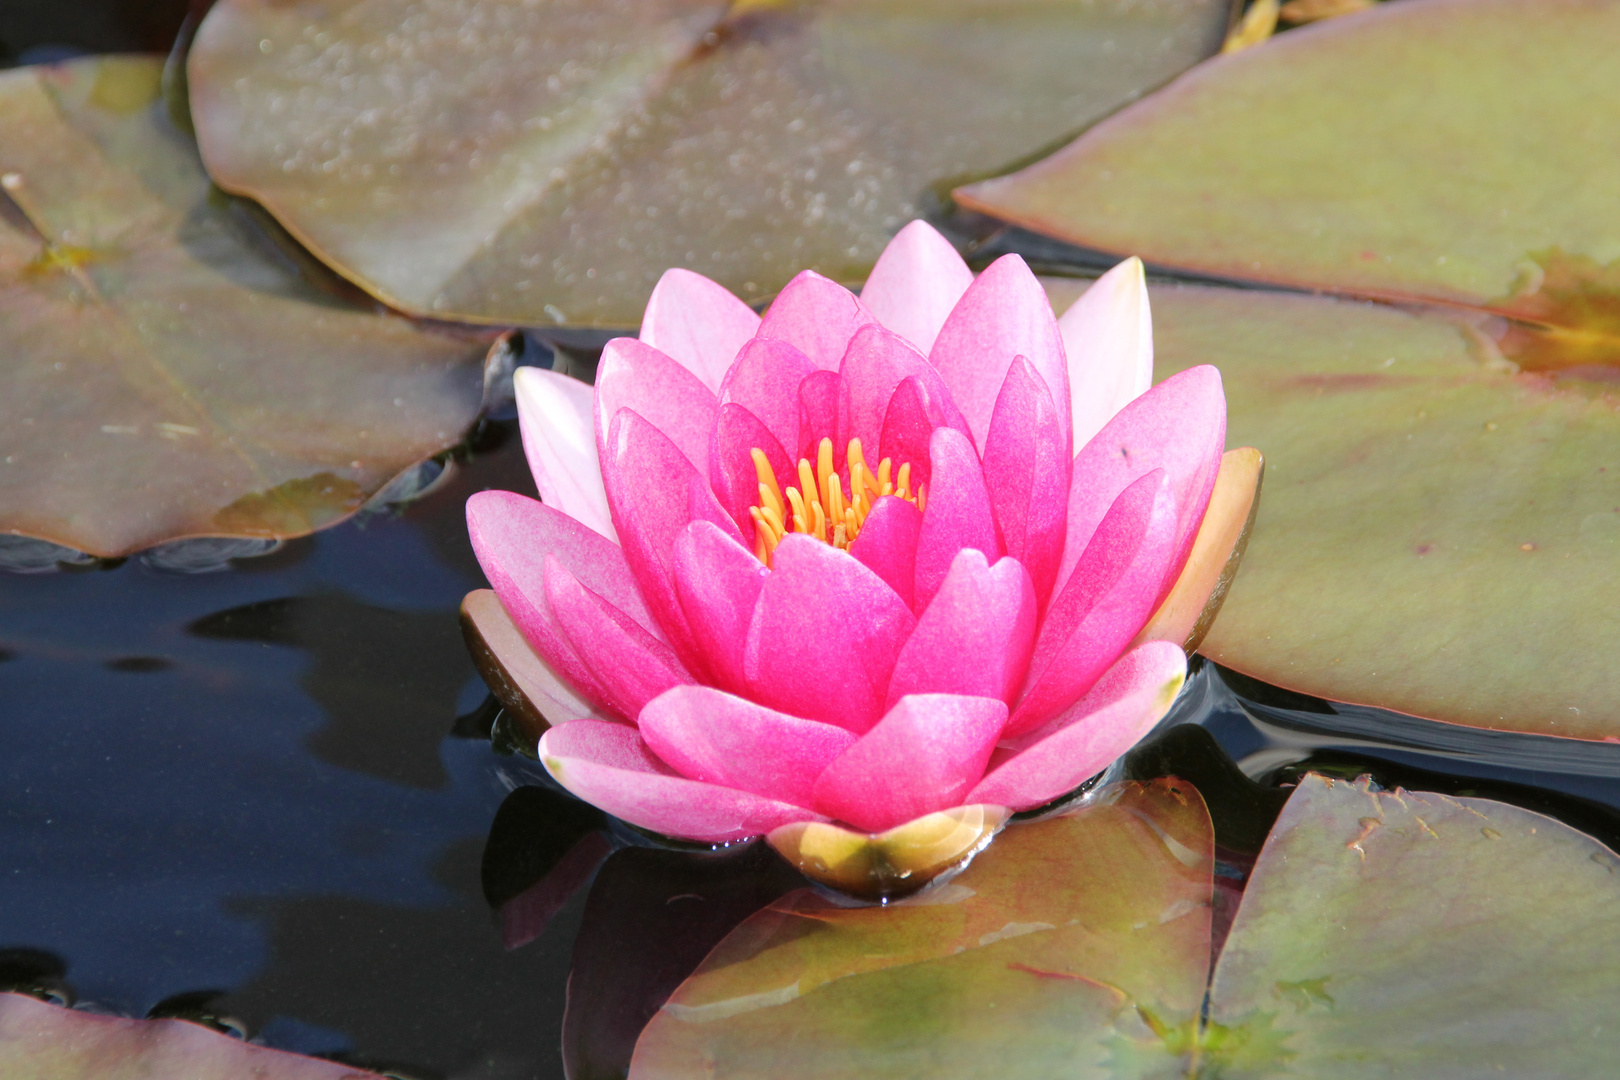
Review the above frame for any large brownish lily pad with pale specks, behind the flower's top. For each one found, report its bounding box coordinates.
[188,0,1230,327]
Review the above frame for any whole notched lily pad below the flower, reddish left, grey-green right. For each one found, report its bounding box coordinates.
[630,776,1620,1080]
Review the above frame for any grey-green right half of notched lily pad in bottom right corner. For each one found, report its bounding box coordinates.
[1197,776,1620,1080]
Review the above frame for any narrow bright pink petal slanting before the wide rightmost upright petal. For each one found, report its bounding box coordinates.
[1008,470,1176,735]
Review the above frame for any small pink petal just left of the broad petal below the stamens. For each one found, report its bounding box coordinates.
[674,521,770,691]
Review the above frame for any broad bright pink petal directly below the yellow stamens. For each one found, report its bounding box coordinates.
[745,533,917,735]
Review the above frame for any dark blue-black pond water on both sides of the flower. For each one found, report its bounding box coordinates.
[0,399,1620,1078]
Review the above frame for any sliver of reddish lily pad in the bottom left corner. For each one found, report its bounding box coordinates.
[0,994,379,1080]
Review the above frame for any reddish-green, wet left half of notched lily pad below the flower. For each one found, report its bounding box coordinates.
[630,780,1213,1080]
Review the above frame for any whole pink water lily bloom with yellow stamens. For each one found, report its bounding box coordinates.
[468,222,1225,842]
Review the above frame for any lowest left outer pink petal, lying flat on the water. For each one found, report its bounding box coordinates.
[539,721,826,844]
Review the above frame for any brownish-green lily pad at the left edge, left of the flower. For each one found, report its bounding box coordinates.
[0,57,488,555]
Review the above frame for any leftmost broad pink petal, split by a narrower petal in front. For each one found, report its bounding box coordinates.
[467,491,659,716]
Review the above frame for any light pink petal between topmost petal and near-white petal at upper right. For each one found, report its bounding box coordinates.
[928,254,1072,447]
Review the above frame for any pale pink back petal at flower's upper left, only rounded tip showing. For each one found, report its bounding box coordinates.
[642,269,760,393]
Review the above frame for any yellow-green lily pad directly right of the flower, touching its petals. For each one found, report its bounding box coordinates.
[1051,283,1620,740]
